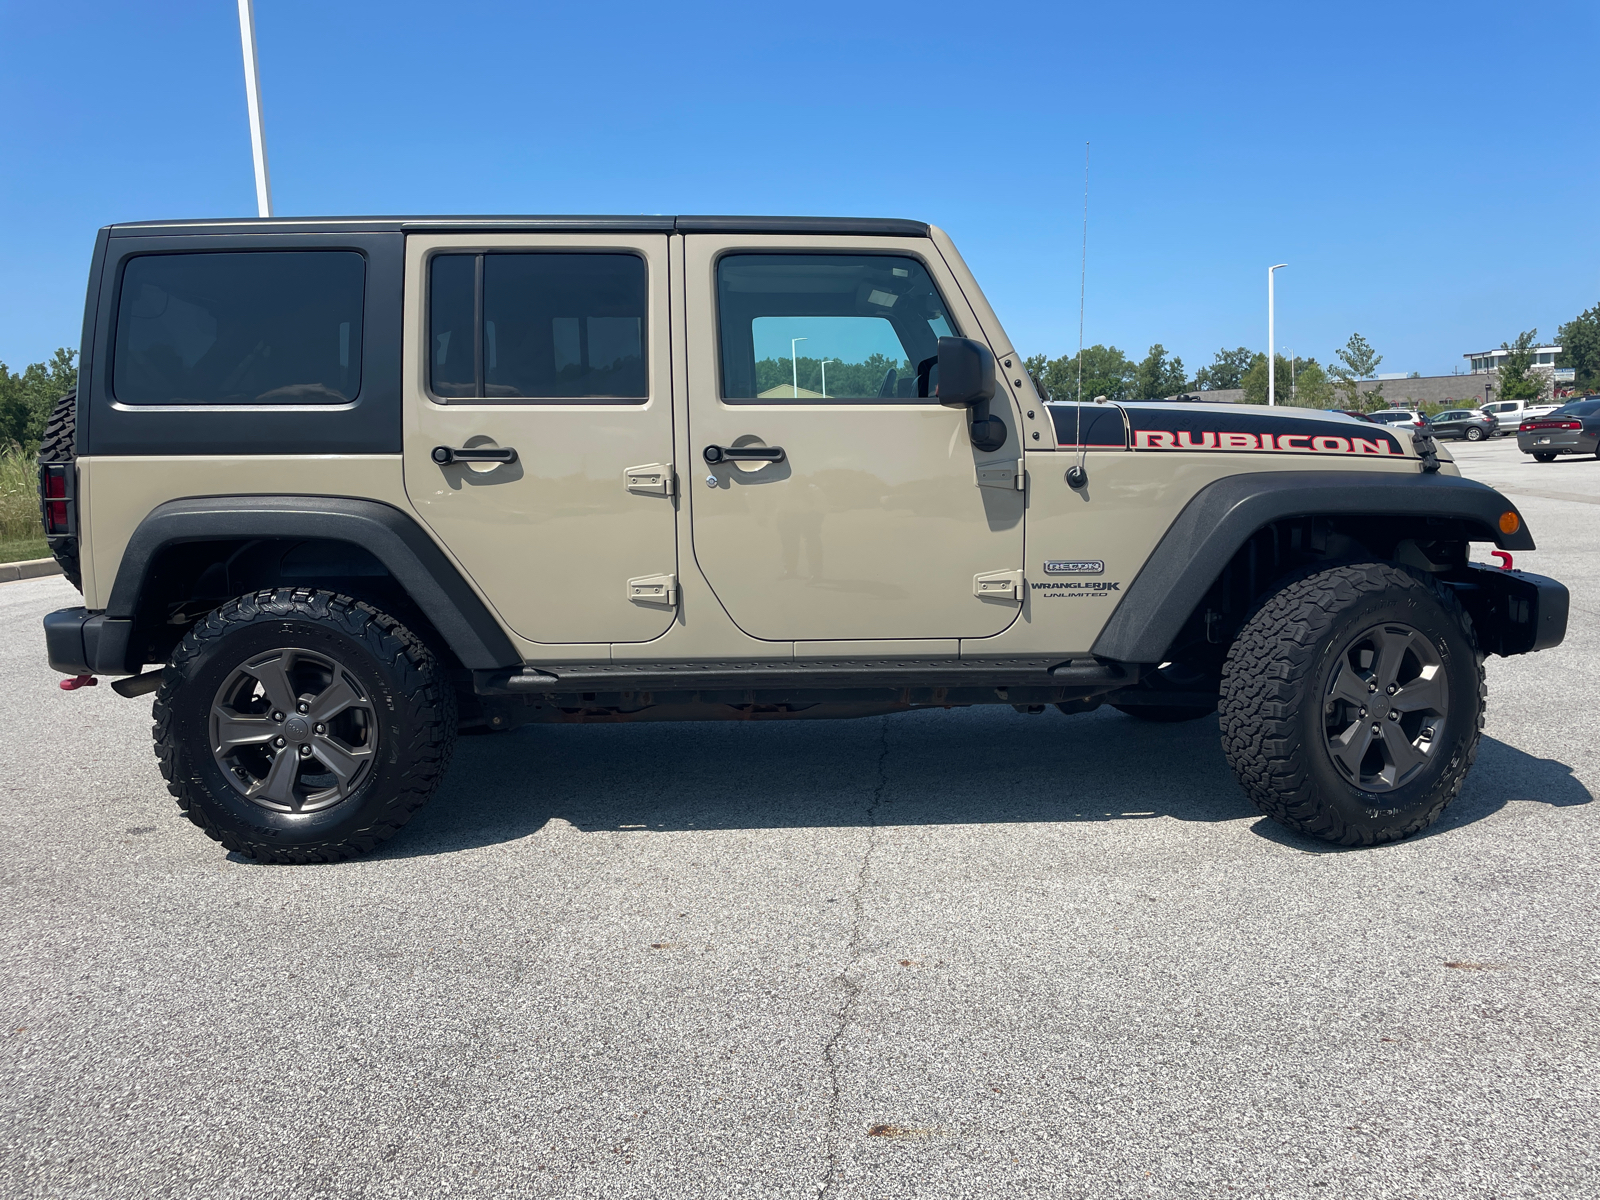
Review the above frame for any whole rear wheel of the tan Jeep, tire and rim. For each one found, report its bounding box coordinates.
[154,587,456,862]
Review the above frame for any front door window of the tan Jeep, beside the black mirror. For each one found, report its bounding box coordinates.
[717,254,955,403]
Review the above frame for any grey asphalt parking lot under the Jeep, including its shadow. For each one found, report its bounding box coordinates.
[0,438,1600,1200]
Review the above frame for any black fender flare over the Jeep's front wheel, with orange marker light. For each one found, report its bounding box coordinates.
[1094,470,1533,662]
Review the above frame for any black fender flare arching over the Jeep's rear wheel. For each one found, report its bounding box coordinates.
[106,496,522,670]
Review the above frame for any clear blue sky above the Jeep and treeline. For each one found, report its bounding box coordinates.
[0,0,1600,374]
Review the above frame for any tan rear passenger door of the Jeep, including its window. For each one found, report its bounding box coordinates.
[405,234,677,650]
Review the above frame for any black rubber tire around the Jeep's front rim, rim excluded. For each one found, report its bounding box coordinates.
[1219,563,1486,846]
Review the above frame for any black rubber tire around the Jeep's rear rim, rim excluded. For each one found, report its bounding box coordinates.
[154,587,456,862]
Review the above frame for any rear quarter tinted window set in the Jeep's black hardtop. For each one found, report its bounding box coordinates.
[112,250,366,405]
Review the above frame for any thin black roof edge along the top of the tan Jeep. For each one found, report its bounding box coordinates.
[107,214,928,237]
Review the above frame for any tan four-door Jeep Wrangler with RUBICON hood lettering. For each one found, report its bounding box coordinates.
[40,218,1566,861]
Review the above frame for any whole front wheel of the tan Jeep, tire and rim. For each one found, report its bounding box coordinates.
[1219,563,1485,846]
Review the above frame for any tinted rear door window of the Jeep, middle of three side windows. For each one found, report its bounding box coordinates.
[429,253,650,400]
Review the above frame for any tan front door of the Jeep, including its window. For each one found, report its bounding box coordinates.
[682,235,1024,640]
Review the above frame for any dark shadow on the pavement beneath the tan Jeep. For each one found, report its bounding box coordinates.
[378,707,1592,858]
